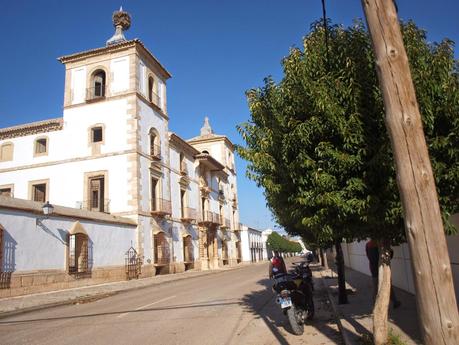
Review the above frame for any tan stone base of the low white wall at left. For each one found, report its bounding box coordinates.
[0,266,126,298]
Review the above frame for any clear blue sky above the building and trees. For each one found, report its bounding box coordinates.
[0,0,459,229]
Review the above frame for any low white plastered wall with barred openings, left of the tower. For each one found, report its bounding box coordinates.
[0,209,136,272]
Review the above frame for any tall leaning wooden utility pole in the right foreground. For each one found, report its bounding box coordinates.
[362,0,459,345]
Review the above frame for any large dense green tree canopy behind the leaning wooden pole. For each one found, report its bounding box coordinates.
[237,22,459,245]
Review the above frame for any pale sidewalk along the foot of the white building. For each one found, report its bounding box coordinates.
[0,261,255,318]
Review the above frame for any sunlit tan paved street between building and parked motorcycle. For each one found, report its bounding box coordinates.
[0,263,341,345]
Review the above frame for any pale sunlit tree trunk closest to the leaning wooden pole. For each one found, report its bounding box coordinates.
[373,242,391,345]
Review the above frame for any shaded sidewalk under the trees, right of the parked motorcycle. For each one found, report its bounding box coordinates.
[321,268,421,345]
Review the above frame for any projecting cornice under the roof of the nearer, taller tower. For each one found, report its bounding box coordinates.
[58,38,172,79]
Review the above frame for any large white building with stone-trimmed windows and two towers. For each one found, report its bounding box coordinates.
[0,7,243,292]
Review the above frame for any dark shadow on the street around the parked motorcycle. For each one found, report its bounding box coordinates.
[242,260,342,344]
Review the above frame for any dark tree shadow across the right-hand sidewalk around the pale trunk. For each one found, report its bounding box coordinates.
[326,265,421,342]
